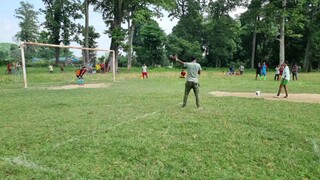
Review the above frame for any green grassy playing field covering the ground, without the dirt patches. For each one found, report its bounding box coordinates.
[0,67,320,179]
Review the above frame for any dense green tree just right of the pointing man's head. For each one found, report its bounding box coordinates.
[206,0,241,67]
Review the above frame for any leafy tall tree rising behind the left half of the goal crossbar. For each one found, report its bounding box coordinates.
[41,0,83,64]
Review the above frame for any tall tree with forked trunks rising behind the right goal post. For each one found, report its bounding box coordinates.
[92,0,174,69]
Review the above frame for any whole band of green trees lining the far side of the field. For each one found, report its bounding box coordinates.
[0,0,320,71]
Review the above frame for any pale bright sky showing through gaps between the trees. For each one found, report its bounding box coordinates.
[0,0,244,55]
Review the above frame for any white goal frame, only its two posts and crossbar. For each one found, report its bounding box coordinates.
[20,42,116,88]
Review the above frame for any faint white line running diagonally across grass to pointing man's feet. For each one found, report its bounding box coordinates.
[53,103,182,148]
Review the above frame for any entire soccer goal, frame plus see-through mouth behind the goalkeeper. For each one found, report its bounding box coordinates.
[20,42,116,88]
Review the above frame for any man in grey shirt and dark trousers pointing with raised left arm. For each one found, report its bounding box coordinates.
[172,56,202,108]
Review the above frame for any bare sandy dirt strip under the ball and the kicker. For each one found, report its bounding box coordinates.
[209,91,320,104]
